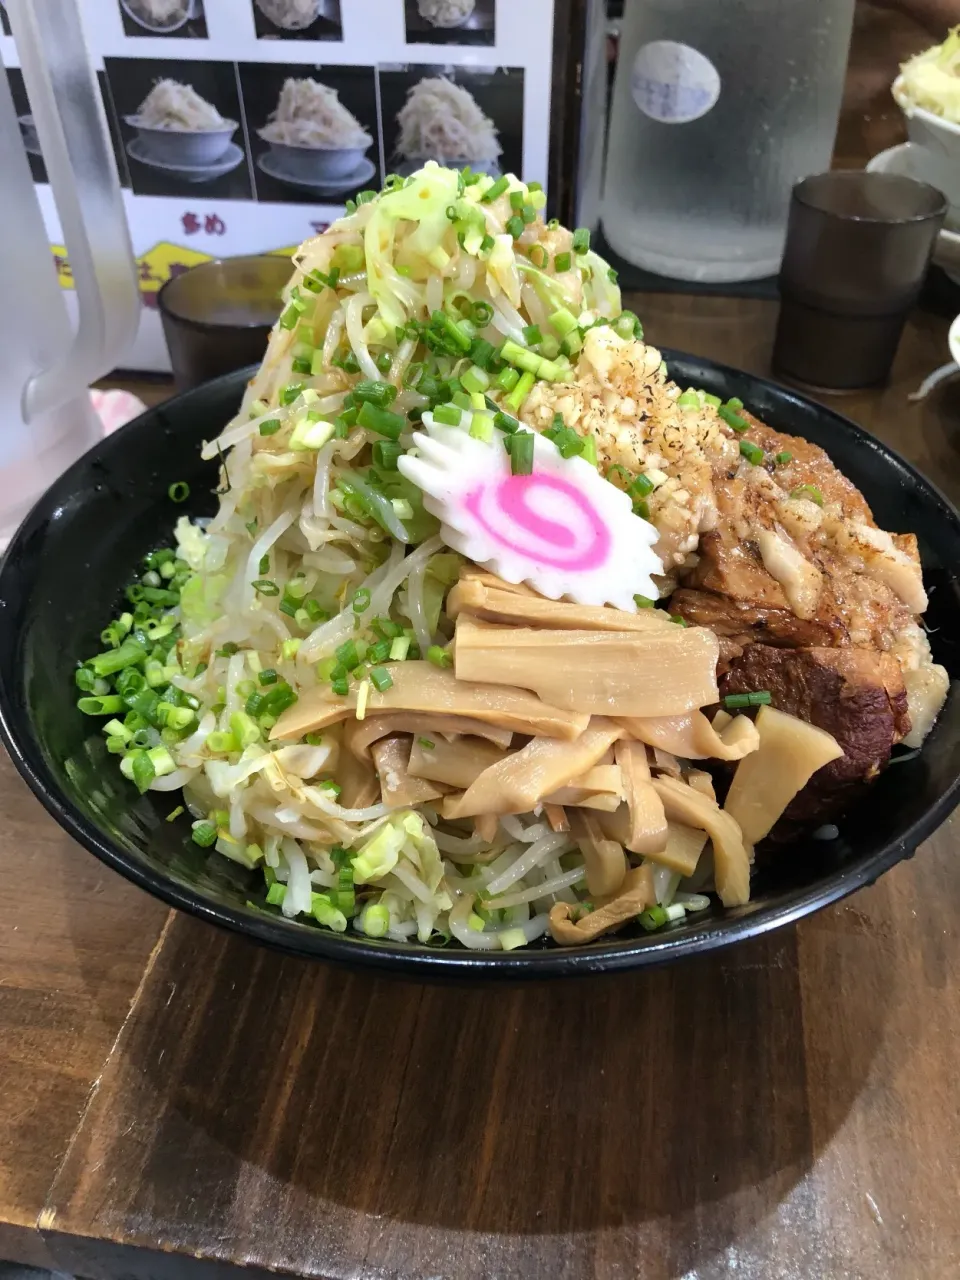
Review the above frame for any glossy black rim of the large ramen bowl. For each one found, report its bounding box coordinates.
[0,360,960,982]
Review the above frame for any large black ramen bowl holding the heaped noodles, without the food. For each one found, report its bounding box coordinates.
[0,352,960,979]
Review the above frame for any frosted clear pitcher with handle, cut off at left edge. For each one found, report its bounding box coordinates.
[0,0,140,534]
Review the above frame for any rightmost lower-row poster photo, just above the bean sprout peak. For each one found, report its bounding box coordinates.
[379,65,524,177]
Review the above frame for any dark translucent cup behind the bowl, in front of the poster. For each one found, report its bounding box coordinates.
[156,253,293,392]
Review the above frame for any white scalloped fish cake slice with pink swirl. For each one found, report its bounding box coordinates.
[398,413,663,613]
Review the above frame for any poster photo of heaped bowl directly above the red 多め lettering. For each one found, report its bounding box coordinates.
[104,58,253,200]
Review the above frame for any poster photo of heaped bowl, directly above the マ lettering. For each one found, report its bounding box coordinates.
[239,63,380,205]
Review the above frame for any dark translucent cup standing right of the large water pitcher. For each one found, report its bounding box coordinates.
[773,170,947,390]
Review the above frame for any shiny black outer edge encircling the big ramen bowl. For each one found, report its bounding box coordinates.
[0,351,960,980]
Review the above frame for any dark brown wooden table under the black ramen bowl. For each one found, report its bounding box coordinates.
[0,297,960,1280]
